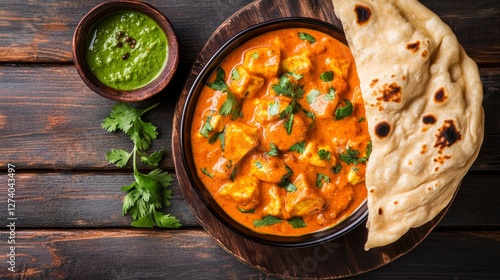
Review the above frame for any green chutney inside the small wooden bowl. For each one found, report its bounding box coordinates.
[86,11,168,90]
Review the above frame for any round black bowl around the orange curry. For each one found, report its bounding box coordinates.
[179,18,368,247]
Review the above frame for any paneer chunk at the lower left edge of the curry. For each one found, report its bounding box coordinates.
[219,175,260,210]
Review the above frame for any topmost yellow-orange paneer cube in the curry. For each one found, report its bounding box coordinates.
[243,46,281,78]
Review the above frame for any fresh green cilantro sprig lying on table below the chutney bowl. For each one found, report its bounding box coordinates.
[102,102,181,228]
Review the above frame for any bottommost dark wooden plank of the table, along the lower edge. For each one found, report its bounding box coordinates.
[0,229,500,279]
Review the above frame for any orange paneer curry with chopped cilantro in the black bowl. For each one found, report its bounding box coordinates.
[191,28,371,236]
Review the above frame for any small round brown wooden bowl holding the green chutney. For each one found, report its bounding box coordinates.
[72,0,179,102]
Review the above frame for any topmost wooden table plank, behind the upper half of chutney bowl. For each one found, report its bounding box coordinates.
[0,0,500,64]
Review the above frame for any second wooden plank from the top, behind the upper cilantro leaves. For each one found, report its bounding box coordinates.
[0,65,500,171]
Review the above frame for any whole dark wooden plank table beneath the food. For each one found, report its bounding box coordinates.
[0,0,500,279]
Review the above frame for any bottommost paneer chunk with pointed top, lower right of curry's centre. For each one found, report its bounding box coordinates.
[285,174,325,217]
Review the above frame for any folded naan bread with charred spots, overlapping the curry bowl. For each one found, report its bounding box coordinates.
[333,0,484,250]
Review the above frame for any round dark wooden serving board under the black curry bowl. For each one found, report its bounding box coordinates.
[172,0,448,279]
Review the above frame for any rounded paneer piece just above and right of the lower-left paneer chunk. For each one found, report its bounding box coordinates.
[250,155,289,183]
